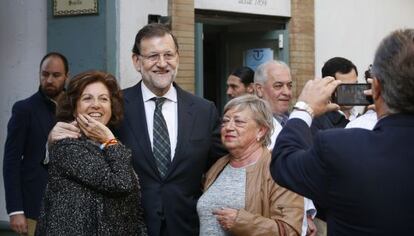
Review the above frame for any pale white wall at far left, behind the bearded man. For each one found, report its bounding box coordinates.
[0,0,47,220]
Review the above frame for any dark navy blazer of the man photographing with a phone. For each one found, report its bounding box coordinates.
[271,114,414,235]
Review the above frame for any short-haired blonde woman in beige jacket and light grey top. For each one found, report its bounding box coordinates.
[197,95,304,235]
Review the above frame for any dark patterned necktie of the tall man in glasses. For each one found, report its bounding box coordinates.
[151,97,171,178]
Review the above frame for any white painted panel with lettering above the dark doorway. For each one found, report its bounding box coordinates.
[194,0,290,17]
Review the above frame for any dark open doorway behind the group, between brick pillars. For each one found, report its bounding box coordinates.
[195,9,289,112]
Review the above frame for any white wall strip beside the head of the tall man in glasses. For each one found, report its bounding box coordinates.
[119,0,168,88]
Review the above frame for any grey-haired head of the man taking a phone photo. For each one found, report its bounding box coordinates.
[372,29,414,114]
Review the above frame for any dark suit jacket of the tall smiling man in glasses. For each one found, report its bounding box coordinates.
[117,82,225,235]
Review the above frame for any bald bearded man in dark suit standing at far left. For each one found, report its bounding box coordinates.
[3,52,68,235]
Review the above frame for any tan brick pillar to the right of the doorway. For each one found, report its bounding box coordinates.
[288,0,315,98]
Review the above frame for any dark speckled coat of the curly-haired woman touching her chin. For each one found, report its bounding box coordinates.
[36,138,146,235]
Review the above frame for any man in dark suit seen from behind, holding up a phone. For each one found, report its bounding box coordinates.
[271,29,414,235]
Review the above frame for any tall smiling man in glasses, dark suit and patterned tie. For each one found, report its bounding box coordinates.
[51,24,225,236]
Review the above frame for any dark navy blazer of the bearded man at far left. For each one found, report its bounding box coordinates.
[3,90,56,219]
